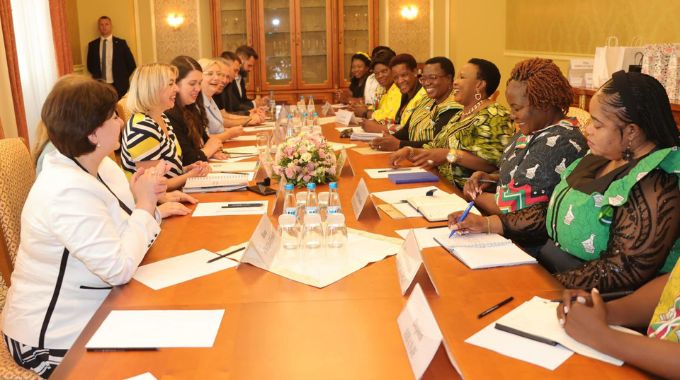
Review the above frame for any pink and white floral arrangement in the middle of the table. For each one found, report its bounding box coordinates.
[274,133,337,187]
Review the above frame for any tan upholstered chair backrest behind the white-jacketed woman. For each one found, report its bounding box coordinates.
[0,138,35,284]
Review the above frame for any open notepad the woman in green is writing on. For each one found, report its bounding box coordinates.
[434,233,536,269]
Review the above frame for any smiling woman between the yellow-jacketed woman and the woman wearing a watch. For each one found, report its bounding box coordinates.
[370,57,463,151]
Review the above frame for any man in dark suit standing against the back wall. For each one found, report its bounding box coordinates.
[87,16,137,98]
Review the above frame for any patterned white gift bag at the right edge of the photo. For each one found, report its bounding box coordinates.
[642,43,680,99]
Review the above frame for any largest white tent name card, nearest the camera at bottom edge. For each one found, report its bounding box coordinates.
[397,284,460,379]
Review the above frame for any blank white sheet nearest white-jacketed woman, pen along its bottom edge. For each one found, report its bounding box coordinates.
[85,309,224,350]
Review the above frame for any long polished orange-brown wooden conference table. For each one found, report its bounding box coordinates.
[52,124,648,379]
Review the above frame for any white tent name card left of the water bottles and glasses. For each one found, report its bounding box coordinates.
[239,215,281,269]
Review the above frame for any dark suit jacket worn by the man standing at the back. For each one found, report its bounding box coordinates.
[87,36,137,97]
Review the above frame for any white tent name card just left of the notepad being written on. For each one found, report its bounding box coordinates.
[397,230,439,294]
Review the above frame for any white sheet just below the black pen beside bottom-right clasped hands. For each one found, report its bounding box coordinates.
[465,320,574,371]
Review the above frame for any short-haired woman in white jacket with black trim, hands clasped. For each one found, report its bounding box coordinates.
[2,75,167,378]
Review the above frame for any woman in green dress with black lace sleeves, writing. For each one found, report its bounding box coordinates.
[449,71,680,292]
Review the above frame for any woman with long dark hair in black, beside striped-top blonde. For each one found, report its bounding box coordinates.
[166,55,227,165]
